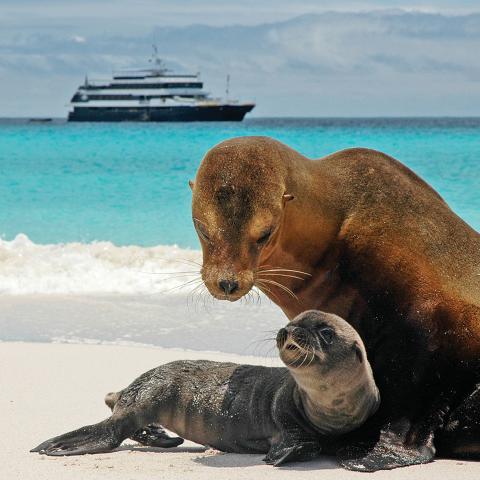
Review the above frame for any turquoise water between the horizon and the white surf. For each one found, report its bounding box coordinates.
[0,118,480,248]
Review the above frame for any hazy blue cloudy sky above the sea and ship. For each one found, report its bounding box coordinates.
[0,0,480,117]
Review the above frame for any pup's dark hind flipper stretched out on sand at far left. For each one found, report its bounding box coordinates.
[30,419,127,456]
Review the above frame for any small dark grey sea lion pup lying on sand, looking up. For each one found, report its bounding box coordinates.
[32,311,380,465]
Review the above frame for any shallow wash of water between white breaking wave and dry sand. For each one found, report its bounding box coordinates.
[0,293,287,356]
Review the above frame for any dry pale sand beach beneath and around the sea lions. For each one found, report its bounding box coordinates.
[0,342,480,480]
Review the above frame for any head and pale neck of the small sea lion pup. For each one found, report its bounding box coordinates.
[277,310,380,433]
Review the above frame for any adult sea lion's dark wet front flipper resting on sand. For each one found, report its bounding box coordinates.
[337,425,435,472]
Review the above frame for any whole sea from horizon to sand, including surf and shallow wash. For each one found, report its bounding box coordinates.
[0,119,480,348]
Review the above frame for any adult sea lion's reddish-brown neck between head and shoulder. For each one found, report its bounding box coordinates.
[259,159,361,319]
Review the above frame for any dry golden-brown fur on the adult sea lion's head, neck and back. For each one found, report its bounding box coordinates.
[193,137,480,355]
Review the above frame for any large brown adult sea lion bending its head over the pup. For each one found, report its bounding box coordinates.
[190,137,480,471]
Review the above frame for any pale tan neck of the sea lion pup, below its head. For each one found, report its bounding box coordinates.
[292,370,380,435]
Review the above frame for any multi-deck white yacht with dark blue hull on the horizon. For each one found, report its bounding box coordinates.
[68,47,255,122]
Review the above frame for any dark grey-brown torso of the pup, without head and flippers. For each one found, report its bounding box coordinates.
[113,360,288,453]
